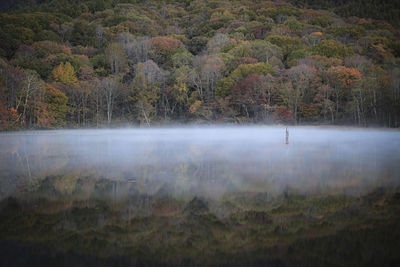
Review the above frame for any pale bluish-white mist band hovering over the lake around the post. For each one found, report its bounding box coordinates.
[0,127,400,201]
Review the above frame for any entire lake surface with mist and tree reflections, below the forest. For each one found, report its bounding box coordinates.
[0,127,400,266]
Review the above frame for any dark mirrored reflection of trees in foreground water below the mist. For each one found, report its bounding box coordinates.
[0,185,400,266]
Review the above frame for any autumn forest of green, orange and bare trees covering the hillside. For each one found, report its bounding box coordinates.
[0,0,400,130]
